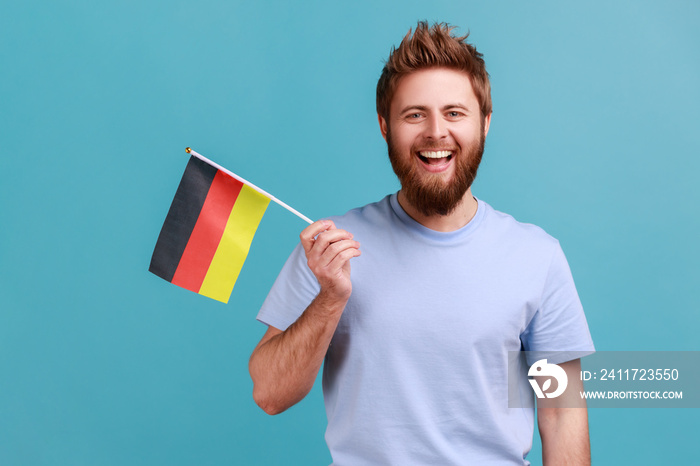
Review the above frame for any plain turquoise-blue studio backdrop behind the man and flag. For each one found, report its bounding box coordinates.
[0,0,700,465]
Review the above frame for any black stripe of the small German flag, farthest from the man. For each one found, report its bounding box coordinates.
[148,156,218,282]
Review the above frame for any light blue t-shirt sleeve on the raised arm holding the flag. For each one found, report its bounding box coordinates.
[257,243,320,330]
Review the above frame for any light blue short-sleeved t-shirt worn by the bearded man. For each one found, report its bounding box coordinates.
[258,194,593,466]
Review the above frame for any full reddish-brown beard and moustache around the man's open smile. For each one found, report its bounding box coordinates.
[386,121,486,216]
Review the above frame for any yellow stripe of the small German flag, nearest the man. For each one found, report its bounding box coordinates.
[199,185,270,303]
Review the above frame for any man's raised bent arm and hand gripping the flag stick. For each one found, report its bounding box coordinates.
[249,220,360,414]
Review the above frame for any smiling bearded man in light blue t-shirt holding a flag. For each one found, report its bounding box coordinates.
[250,22,593,466]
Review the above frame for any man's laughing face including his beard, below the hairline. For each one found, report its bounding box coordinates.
[379,68,491,216]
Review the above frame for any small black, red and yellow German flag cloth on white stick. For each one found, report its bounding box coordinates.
[148,156,270,303]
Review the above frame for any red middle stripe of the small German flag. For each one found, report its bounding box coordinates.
[172,171,243,293]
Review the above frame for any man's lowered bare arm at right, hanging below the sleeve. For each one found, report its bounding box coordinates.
[537,359,591,466]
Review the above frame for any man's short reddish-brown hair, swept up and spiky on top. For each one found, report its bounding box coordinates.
[377,21,491,121]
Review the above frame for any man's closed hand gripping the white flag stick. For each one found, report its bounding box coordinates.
[299,220,360,301]
